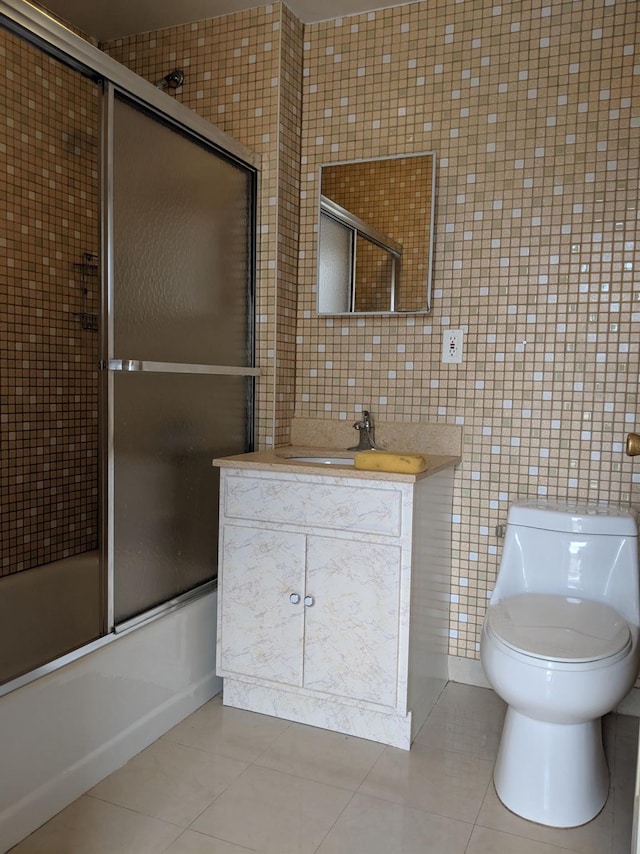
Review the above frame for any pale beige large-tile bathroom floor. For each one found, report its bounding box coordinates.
[13,683,638,854]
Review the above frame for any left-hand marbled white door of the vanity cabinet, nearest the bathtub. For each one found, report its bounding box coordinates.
[219,523,305,685]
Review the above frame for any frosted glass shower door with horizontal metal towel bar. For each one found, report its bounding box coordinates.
[104,95,257,626]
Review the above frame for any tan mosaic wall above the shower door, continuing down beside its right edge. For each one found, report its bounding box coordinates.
[102,3,302,446]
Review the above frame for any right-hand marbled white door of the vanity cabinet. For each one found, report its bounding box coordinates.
[303,536,400,707]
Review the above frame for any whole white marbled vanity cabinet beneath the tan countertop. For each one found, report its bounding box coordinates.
[217,467,453,748]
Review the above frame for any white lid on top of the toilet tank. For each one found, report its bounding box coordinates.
[507,501,638,537]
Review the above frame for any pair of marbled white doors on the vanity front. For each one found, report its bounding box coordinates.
[219,522,400,706]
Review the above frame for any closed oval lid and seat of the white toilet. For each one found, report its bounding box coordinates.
[485,593,631,665]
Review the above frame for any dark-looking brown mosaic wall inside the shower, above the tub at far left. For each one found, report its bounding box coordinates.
[0,31,99,575]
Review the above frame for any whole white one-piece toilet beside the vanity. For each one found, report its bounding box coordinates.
[480,503,640,827]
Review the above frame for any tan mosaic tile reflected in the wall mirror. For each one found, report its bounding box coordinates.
[322,156,433,311]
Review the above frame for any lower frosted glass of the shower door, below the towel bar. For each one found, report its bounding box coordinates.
[114,374,251,623]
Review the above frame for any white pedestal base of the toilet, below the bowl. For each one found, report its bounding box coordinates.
[493,707,609,827]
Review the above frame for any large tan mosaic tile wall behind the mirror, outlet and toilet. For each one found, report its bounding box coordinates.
[296,0,640,658]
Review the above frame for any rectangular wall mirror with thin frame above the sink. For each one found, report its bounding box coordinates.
[318,152,436,314]
